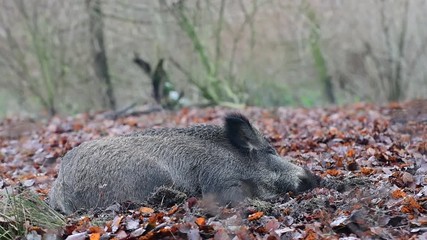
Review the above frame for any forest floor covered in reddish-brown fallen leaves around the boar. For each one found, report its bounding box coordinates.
[0,101,427,240]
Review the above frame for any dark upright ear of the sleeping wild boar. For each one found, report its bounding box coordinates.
[224,113,263,151]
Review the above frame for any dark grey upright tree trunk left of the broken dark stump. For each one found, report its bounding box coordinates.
[86,0,116,110]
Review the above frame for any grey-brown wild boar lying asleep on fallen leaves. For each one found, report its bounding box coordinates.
[49,113,319,213]
